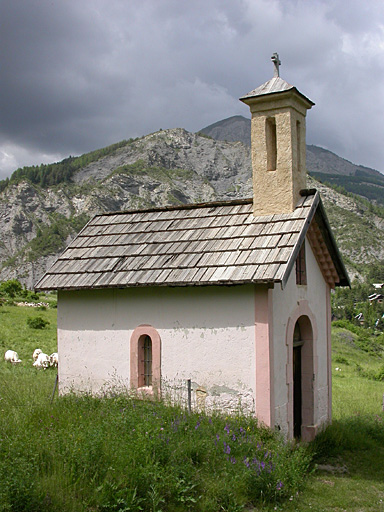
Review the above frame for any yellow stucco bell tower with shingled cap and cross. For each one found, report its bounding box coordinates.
[240,53,314,215]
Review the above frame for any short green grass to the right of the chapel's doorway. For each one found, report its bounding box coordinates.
[277,328,384,512]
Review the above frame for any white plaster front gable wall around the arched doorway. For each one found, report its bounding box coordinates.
[273,240,328,433]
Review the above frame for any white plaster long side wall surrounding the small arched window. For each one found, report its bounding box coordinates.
[58,286,255,411]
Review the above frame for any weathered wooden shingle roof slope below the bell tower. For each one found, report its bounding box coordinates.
[36,189,348,290]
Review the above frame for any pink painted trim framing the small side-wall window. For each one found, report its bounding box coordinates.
[130,325,161,394]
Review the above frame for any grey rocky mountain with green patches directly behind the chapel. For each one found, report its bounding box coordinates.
[0,128,384,287]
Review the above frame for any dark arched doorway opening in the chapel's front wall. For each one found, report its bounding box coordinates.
[292,315,315,439]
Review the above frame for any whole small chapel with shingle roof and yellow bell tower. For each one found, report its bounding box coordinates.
[36,54,349,440]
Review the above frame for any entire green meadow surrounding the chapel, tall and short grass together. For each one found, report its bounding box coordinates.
[0,296,384,512]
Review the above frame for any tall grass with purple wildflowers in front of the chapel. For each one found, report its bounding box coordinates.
[0,374,310,512]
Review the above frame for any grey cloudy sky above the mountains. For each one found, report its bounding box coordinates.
[0,0,384,179]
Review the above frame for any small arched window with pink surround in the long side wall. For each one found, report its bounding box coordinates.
[130,325,161,393]
